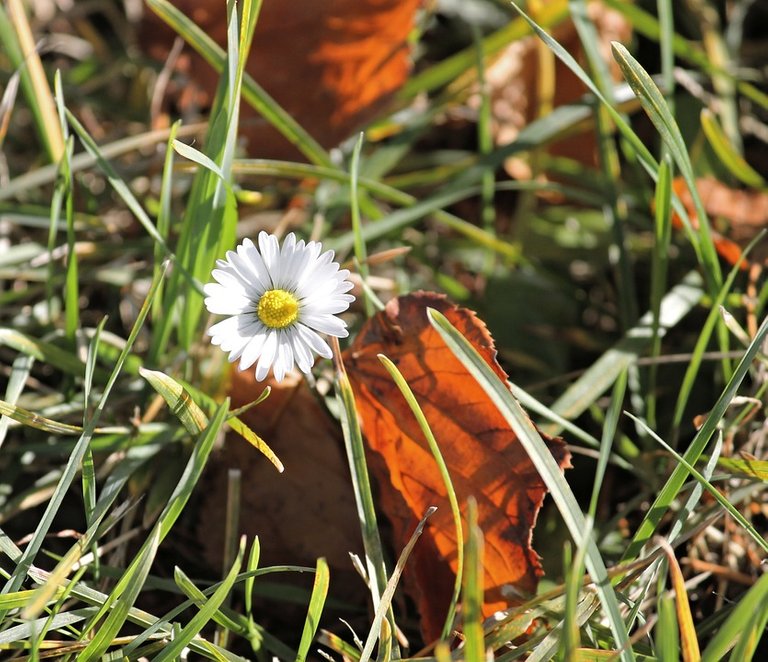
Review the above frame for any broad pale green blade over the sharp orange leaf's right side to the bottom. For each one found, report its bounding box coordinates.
[428,309,634,660]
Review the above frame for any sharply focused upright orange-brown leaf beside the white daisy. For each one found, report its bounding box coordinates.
[344,292,569,640]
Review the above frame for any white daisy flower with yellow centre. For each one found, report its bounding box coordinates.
[204,232,355,382]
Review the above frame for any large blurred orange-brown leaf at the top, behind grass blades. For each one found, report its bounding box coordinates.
[140,0,421,158]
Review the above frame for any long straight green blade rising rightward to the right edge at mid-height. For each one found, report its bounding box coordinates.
[623,318,768,560]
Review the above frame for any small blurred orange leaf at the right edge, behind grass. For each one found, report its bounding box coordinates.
[672,177,768,269]
